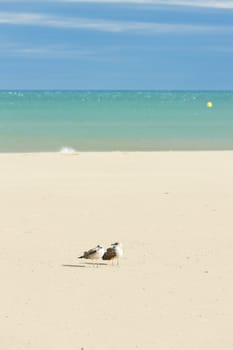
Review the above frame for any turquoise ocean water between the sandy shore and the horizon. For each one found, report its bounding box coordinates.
[0,91,233,153]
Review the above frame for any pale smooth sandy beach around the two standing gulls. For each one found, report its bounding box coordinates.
[0,151,233,350]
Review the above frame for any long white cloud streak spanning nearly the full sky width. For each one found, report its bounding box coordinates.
[0,12,230,34]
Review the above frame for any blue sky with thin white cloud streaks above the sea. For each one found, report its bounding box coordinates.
[0,0,233,90]
